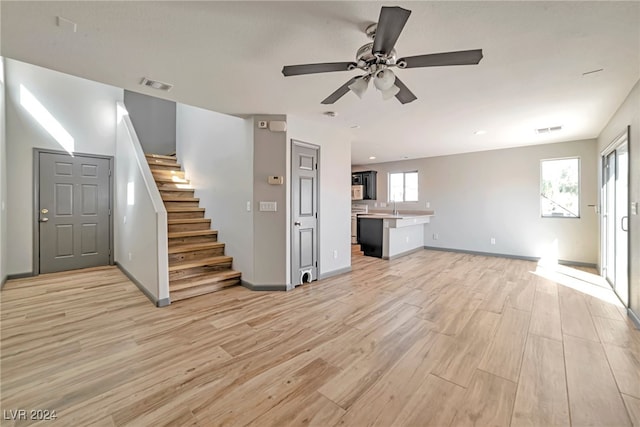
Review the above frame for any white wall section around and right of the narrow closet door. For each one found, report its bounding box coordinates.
[287,115,351,277]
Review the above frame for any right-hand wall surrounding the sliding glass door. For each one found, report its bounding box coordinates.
[596,80,640,317]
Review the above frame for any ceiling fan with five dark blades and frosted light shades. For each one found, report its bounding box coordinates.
[282,6,482,104]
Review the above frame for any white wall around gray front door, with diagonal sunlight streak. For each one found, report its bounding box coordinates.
[5,59,123,275]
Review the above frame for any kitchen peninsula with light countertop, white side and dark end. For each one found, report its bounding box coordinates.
[358,213,433,259]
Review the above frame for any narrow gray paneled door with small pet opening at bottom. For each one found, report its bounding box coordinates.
[291,142,318,286]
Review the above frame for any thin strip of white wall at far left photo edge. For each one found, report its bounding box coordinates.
[0,56,7,286]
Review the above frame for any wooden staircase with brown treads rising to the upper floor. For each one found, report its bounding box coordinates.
[146,154,241,302]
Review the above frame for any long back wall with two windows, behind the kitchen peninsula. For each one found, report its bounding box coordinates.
[354,140,598,264]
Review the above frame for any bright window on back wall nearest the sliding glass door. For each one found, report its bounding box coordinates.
[540,158,580,218]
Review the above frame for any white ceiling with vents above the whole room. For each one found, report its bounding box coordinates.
[0,0,640,164]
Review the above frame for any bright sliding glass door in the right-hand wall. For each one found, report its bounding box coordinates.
[600,130,629,307]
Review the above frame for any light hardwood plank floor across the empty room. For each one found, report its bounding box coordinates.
[0,250,640,427]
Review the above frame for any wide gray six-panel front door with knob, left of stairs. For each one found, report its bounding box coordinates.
[37,152,111,273]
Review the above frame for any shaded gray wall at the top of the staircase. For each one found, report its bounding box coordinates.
[124,90,176,154]
